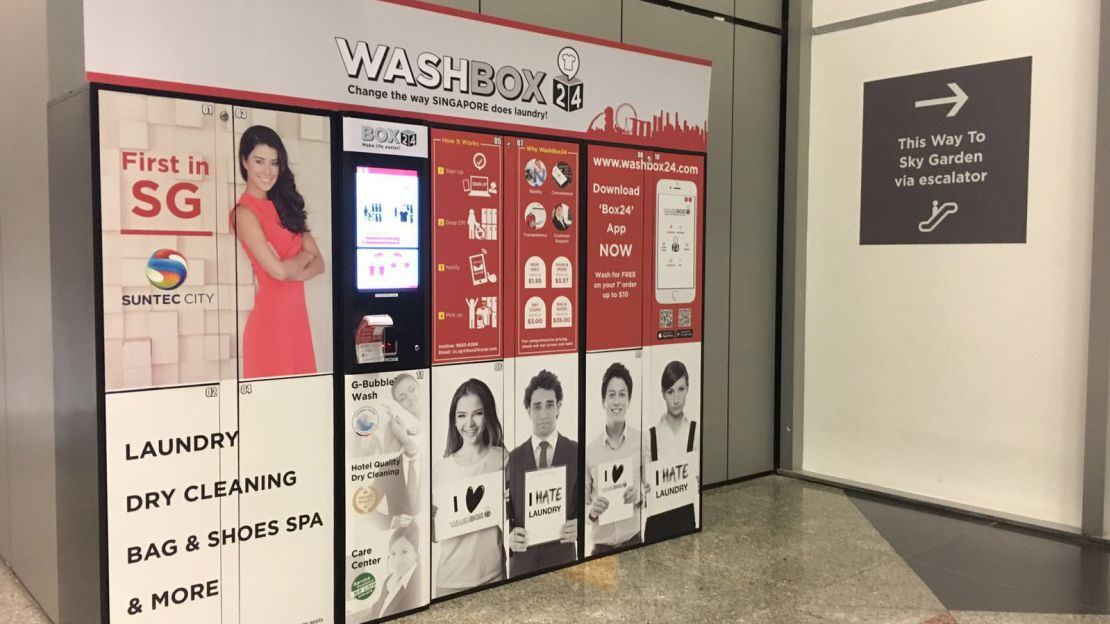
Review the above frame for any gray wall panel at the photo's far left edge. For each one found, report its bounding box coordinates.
[0,0,59,618]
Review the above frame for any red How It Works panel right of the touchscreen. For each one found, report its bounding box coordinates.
[432,130,505,364]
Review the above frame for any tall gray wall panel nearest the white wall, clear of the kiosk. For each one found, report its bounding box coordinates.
[728,27,783,479]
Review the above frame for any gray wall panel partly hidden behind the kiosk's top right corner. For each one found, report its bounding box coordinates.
[624,1,737,483]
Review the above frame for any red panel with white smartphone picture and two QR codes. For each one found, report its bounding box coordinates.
[644,152,705,344]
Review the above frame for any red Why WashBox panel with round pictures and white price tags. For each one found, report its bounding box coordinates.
[506,139,581,355]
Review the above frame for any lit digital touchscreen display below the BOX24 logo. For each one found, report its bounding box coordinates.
[354,167,420,291]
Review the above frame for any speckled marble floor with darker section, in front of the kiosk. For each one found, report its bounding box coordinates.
[0,476,1110,624]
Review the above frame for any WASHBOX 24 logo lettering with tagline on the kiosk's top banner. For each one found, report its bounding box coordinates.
[335,37,585,113]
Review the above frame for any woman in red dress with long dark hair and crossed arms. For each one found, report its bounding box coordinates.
[232,125,324,378]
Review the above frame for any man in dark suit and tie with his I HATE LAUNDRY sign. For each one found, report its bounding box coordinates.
[505,371,579,577]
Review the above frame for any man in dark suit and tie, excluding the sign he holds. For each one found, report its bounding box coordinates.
[505,370,581,577]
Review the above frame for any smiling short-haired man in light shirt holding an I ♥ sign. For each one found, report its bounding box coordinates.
[586,362,643,555]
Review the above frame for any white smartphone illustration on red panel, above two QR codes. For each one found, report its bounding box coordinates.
[655,180,698,303]
